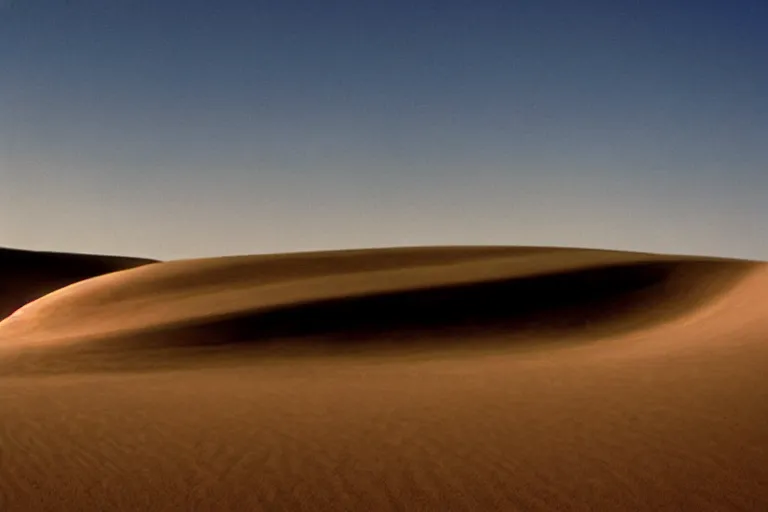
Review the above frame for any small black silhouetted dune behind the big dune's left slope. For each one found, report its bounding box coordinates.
[0,248,153,319]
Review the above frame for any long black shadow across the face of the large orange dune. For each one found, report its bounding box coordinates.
[129,262,745,353]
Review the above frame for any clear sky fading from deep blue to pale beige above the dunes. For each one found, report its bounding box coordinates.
[0,0,768,260]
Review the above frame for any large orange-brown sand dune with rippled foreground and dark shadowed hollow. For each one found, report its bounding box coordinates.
[0,247,768,511]
